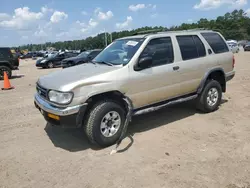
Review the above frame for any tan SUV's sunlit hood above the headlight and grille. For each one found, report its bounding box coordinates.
[38,63,120,91]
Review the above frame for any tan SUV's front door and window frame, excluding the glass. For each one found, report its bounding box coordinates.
[127,34,187,109]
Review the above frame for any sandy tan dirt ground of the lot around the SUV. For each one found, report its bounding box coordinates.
[0,52,250,188]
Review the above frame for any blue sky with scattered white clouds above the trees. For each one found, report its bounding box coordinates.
[0,0,250,46]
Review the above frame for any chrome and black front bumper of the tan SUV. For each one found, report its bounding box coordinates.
[34,94,87,128]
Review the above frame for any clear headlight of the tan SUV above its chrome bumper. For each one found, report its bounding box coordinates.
[49,90,73,104]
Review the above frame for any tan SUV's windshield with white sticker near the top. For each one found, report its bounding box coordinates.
[93,38,145,65]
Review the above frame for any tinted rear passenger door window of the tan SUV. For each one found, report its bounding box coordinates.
[176,35,206,60]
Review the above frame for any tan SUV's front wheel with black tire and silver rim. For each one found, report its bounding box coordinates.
[84,100,125,147]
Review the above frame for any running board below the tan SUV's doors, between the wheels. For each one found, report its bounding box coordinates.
[133,94,198,116]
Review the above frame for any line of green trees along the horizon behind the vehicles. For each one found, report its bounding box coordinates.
[19,10,250,50]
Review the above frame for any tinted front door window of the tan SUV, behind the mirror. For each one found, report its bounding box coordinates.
[141,37,174,66]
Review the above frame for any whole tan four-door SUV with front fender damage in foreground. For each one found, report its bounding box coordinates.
[35,30,235,147]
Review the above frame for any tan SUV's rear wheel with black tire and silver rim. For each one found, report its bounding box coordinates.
[197,80,222,113]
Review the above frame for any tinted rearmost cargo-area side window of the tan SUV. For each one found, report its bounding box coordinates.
[201,33,229,54]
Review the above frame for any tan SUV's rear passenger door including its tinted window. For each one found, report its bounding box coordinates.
[171,35,209,96]
